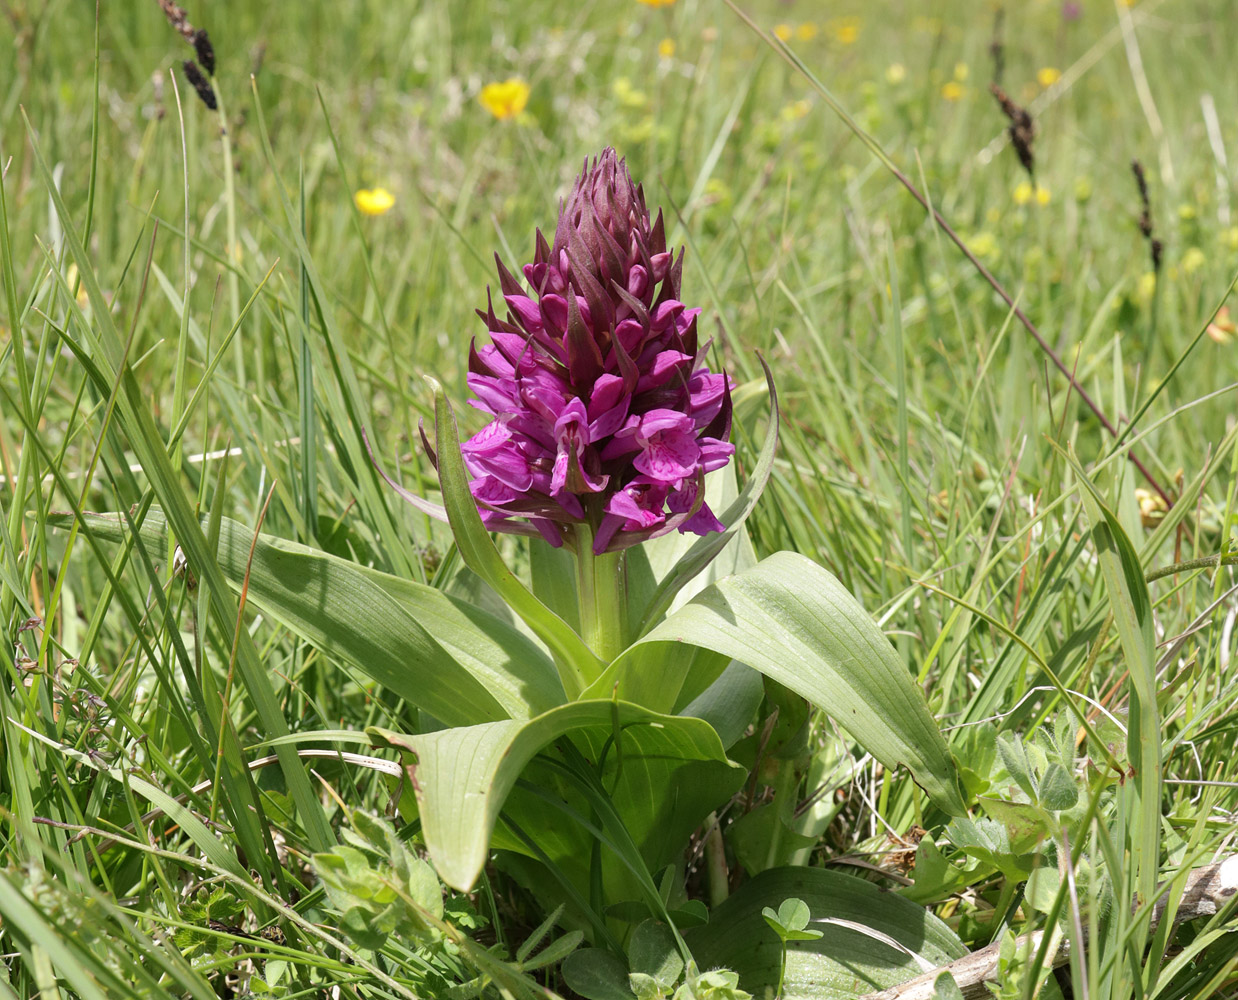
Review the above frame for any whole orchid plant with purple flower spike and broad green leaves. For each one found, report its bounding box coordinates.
[77,150,966,996]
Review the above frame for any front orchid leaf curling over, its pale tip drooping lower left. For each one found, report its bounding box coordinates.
[366,700,743,890]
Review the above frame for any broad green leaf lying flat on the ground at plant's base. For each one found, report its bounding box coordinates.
[685,868,967,1000]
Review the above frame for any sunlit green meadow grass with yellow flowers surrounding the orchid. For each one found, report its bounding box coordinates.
[0,0,1238,998]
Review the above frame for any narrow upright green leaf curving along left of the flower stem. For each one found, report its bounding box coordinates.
[428,379,602,698]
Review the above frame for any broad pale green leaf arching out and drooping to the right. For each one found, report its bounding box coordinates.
[628,552,966,816]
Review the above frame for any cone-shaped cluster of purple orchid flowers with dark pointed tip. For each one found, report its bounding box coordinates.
[463,149,734,554]
